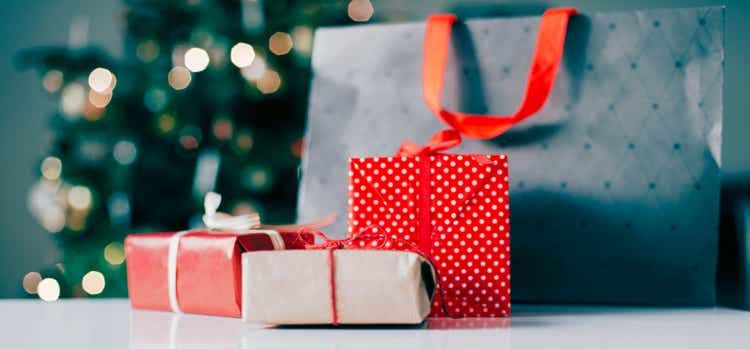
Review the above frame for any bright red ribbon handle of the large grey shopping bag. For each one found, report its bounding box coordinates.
[422,8,578,139]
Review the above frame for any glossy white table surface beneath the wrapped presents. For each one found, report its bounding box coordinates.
[0,299,750,349]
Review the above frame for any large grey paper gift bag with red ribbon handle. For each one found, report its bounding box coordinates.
[298,7,724,304]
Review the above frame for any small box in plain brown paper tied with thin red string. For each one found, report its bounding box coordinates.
[242,250,435,325]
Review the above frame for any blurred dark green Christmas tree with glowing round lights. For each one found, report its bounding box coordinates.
[16,0,373,300]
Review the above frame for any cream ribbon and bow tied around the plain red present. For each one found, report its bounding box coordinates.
[167,192,335,313]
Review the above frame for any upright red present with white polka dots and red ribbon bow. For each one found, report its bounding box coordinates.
[349,130,510,317]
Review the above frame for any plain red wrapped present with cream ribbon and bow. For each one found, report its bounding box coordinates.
[125,193,313,317]
